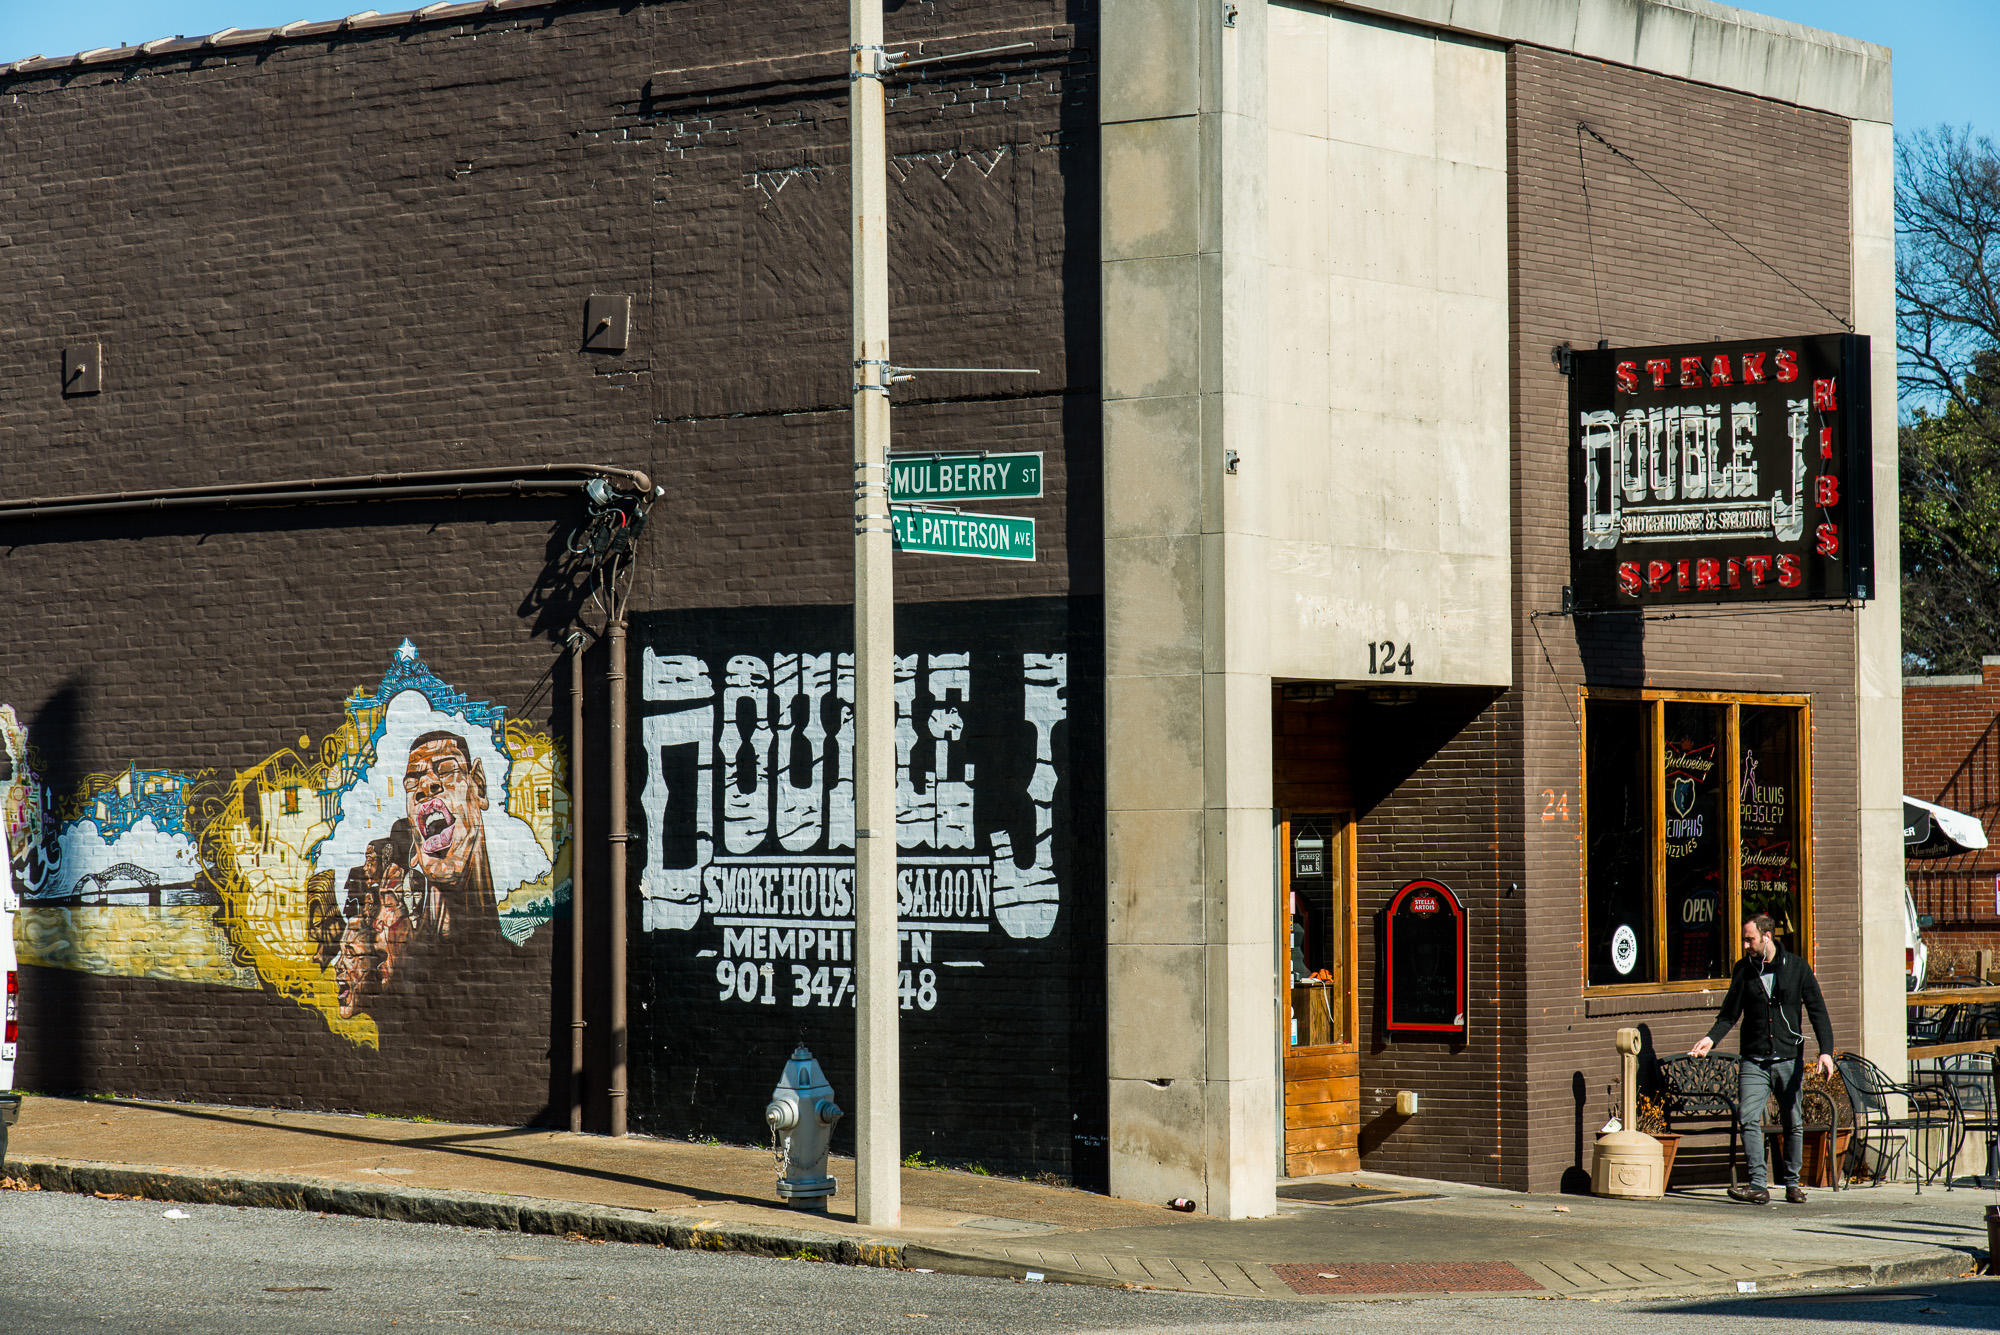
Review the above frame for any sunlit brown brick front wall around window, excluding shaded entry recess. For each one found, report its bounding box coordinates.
[1502,48,1858,1189]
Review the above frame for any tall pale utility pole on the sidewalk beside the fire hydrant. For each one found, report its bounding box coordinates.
[848,0,902,1229]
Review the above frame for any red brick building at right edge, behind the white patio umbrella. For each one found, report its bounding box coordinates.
[1902,660,2000,959]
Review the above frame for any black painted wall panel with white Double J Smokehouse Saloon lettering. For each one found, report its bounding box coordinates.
[630,598,1102,1173]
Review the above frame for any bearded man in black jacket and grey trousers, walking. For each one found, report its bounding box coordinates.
[1688,913,1834,1205]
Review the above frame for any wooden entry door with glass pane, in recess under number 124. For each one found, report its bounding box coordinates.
[1278,811,1360,1177]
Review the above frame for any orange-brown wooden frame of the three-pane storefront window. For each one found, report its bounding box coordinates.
[1576,685,1818,997]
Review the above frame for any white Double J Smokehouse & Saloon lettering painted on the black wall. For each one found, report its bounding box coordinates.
[638,646,1068,1011]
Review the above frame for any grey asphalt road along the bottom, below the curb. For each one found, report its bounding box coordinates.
[0,1191,2000,1335]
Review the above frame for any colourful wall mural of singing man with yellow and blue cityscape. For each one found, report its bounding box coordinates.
[0,640,570,1045]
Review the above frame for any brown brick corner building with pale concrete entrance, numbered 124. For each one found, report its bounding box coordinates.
[0,0,1902,1215]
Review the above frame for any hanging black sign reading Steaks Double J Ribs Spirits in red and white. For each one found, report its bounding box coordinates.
[1570,334,1874,610]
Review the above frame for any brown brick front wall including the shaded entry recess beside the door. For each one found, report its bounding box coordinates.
[1278,48,1858,1189]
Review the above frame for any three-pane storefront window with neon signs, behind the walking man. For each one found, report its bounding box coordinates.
[1584,691,1812,987]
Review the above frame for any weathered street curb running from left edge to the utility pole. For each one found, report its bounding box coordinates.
[0,1155,906,1269]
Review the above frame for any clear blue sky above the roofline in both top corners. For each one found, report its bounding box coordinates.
[0,0,2000,138]
